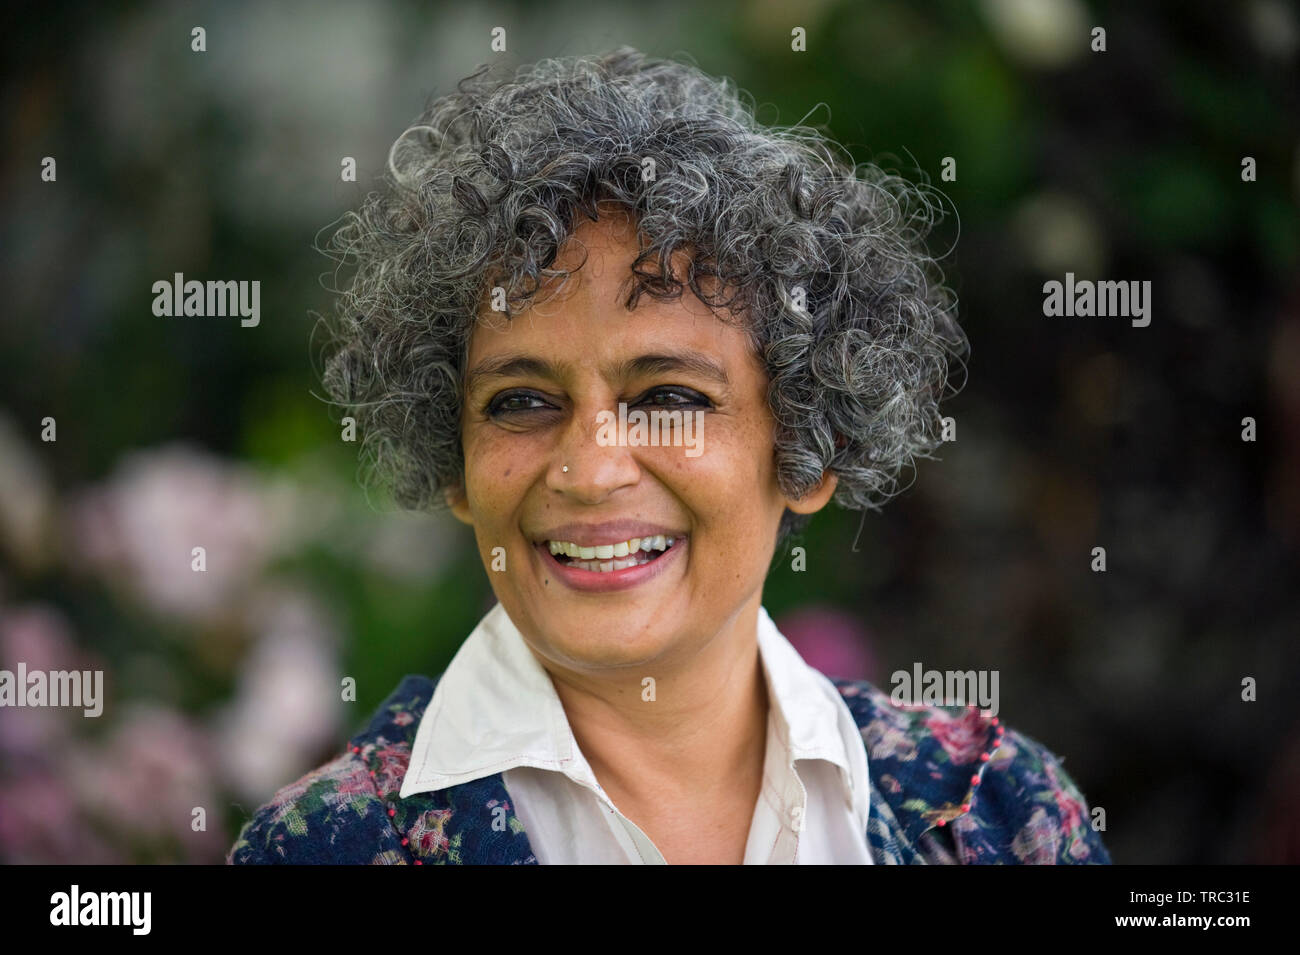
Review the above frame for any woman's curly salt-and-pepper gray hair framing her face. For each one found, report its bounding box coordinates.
[321,47,969,547]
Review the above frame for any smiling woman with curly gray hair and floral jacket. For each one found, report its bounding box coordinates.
[230,48,1109,864]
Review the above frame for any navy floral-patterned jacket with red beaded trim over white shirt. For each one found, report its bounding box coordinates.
[226,676,1110,865]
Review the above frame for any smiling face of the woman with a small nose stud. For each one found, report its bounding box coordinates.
[449,206,835,674]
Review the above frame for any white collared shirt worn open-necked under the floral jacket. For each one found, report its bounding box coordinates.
[402,603,871,865]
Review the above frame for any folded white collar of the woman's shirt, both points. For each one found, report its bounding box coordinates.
[400,603,862,799]
